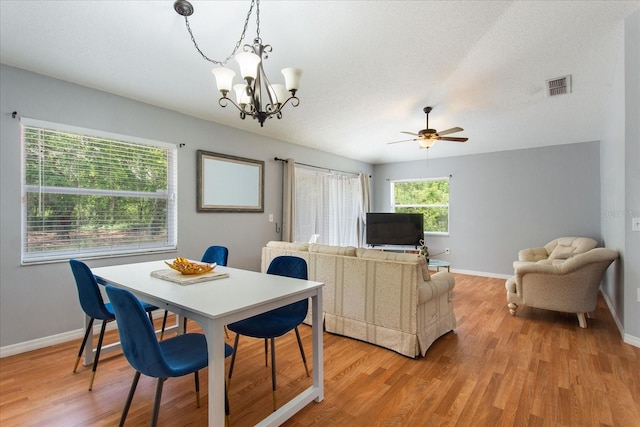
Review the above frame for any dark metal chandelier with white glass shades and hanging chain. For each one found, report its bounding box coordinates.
[173,0,302,127]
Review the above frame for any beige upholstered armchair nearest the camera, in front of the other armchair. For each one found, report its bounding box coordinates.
[505,248,618,328]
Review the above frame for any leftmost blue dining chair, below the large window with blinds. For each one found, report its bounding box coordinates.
[69,259,164,390]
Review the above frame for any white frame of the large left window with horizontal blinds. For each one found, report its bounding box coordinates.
[20,117,178,265]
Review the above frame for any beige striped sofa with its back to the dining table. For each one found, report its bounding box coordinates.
[262,242,456,357]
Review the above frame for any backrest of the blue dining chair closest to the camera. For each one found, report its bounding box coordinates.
[106,285,171,378]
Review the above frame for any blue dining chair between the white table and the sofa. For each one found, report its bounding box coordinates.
[227,255,309,411]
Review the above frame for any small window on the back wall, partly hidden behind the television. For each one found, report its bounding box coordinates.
[391,178,449,234]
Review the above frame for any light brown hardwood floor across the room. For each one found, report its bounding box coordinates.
[0,274,640,427]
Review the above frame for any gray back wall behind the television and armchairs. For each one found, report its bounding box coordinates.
[373,141,600,277]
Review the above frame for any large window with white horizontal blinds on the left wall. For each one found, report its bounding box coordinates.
[21,118,177,264]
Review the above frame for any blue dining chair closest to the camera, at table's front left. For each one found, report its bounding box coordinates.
[107,285,233,426]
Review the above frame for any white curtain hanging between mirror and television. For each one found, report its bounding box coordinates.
[294,166,363,246]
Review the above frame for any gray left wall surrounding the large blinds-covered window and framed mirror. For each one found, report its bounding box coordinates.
[0,65,372,347]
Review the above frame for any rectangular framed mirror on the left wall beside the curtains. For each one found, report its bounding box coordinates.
[196,150,264,212]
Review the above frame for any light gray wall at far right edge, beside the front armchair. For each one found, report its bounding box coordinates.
[600,11,640,346]
